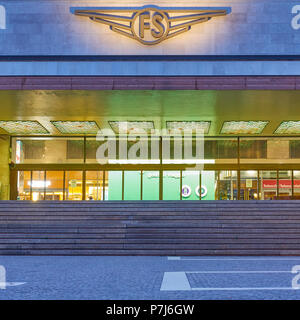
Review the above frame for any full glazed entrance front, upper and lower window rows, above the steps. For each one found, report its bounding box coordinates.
[10,137,300,201]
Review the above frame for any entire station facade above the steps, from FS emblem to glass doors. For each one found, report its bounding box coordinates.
[0,0,300,201]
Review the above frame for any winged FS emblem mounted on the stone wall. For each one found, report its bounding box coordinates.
[71,6,231,45]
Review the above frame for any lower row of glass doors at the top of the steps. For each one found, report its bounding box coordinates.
[16,170,300,201]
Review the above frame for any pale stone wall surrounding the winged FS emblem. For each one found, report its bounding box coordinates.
[0,0,300,55]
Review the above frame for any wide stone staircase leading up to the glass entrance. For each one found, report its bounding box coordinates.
[0,200,300,256]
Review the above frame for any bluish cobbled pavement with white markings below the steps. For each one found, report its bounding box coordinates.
[0,256,300,300]
